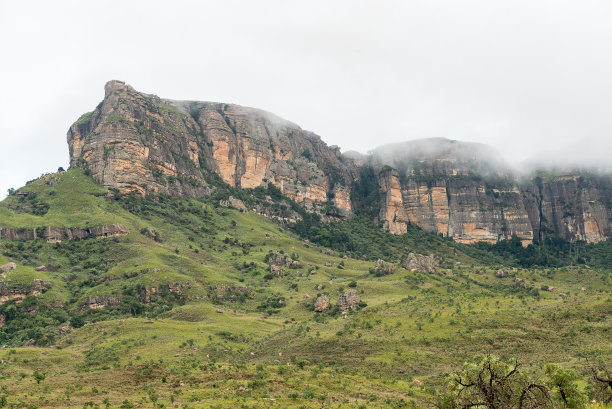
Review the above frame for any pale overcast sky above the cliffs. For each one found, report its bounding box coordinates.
[0,0,612,198]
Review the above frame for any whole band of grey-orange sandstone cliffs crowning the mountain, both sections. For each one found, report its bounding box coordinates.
[68,81,612,245]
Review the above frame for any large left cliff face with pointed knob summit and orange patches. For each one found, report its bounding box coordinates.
[68,81,357,215]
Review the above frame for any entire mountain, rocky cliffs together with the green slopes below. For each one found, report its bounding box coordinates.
[0,81,612,409]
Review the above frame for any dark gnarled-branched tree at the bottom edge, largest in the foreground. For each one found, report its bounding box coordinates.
[436,355,553,409]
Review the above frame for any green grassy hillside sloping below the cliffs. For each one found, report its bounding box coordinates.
[0,169,612,408]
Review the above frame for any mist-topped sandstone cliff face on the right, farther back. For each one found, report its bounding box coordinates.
[370,141,612,245]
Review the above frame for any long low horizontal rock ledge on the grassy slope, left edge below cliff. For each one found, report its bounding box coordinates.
[0,224,130,243]
